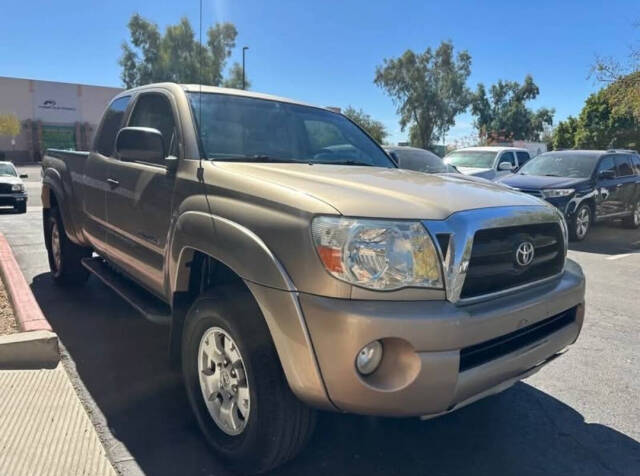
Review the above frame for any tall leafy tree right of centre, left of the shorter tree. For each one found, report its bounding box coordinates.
[374,42,471,149]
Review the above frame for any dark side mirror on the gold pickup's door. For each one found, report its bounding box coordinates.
[116,127,165,163]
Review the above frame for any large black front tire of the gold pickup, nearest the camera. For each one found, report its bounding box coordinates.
[182,285,315,474]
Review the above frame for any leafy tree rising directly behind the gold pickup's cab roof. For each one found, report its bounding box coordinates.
[119,14,248,88]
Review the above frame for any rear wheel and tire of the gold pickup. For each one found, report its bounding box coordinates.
[44,207,91,285]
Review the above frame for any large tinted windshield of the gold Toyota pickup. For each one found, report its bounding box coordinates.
[187,92,395,167]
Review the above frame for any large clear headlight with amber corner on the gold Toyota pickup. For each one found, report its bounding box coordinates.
[311,217,443,291]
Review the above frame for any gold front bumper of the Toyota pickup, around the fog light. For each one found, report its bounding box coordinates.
[300,260,585,416]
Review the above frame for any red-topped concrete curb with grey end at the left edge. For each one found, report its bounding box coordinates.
[0,233,60,368]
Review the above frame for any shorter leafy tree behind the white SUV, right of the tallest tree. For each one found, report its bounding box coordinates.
[471,75,555,142]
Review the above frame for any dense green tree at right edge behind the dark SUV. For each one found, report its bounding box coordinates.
[575,88,640,149]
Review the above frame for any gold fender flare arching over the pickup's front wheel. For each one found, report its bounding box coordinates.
[165,211,335,409]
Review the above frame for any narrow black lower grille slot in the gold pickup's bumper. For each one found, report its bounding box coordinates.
[460,307,576,372]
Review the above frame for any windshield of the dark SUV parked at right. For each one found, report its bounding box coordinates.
[518,153,598,178]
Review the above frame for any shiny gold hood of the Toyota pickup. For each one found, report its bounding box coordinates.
[215,162,541,220]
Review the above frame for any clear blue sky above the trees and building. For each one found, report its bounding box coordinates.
[0,0,640,141]
